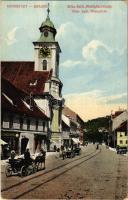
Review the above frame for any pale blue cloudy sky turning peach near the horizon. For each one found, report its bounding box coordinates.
[0,0,127,121]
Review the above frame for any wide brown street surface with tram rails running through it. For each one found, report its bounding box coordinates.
[1,144,128,200]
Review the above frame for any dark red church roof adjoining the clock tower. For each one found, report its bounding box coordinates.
[1,61,52,95]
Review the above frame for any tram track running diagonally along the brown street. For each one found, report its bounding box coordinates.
[1,150,100,199]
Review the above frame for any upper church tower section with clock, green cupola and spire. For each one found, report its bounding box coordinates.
[33,4,61,76]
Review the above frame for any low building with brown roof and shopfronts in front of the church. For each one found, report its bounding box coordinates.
[1,78,49,158]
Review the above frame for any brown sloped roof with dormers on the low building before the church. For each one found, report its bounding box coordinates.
[1,78,48,120]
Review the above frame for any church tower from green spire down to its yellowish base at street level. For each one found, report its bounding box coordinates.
[33,4,63,146]
